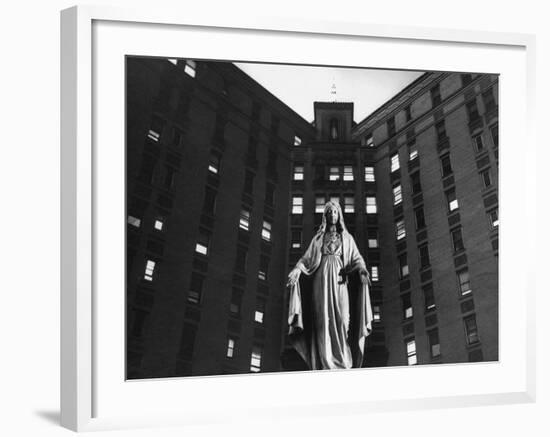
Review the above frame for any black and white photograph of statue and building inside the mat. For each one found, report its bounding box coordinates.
[125,55,499,379]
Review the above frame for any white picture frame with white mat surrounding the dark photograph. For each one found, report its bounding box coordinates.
[61,6,536,431]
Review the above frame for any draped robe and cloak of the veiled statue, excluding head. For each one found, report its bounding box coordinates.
[288,221,373,369]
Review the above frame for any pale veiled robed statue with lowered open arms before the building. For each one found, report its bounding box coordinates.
[287,202,373,370]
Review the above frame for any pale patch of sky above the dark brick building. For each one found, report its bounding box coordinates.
[235,63,424,122]
